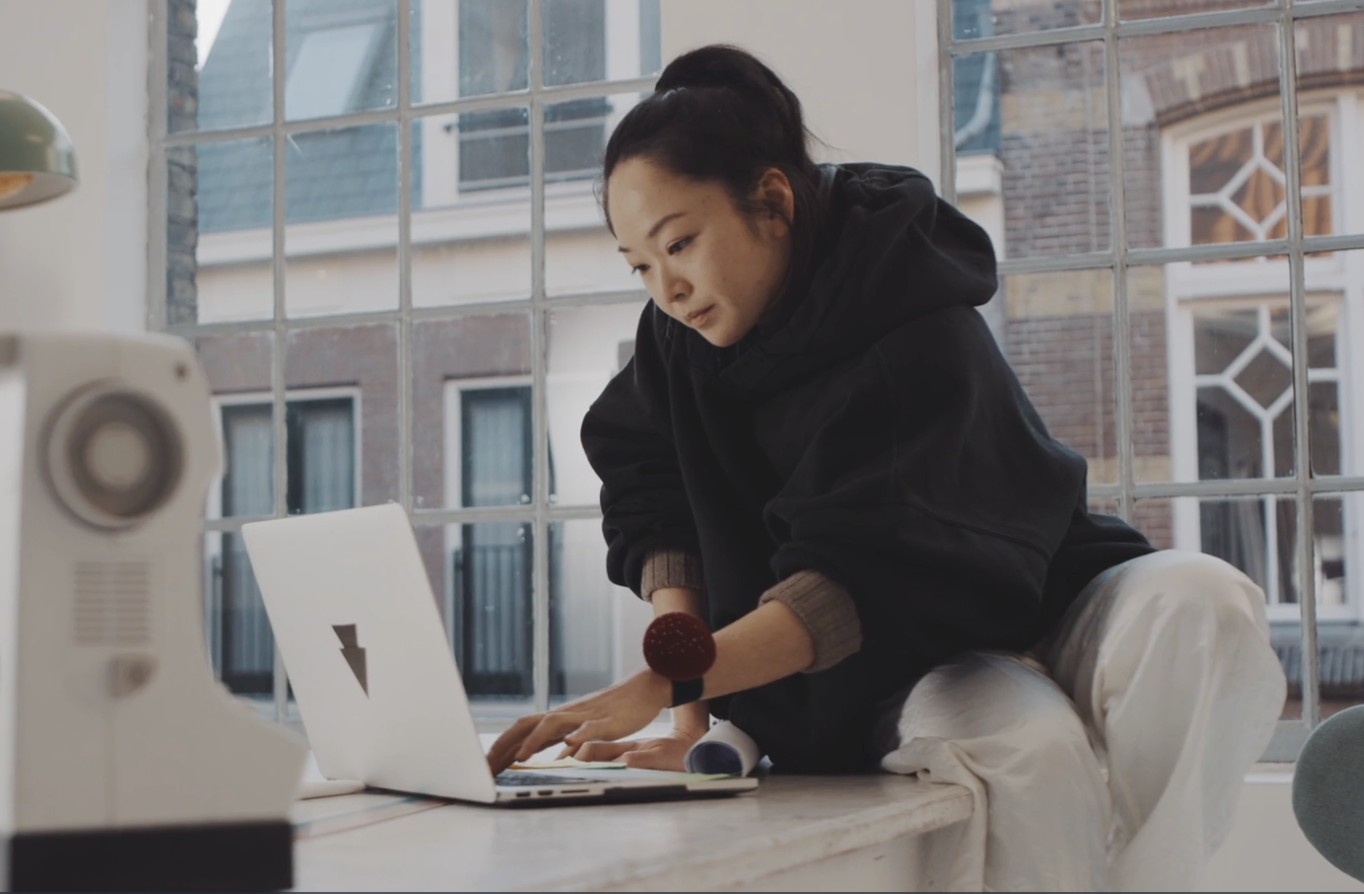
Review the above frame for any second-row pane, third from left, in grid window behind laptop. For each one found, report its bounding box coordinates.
[411,109,531,307]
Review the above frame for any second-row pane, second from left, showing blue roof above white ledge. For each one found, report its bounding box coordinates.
[285,124,398,317]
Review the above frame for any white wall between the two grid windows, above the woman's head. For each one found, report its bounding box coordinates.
[663,0,940,183]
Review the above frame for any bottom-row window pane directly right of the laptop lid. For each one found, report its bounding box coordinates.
[441,521,535,702]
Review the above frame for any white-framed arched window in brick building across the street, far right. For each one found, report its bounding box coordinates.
[1163,90,1364,620]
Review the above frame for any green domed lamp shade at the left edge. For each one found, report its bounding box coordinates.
[0,90,78,210]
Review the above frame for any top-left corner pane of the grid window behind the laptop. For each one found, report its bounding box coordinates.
[174,0,274,134]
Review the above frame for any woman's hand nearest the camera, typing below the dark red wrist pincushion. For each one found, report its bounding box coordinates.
[488,670,671,775]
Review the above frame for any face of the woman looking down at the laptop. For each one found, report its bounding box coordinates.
[607,157,794,348]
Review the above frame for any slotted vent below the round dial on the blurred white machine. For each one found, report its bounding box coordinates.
[72,561,151,646]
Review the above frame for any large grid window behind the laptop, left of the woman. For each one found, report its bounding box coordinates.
[149,0,660,723]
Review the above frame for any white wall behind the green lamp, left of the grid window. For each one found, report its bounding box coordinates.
[0,0,147,330]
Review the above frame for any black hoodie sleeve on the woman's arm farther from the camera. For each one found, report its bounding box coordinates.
[582,302,701,595]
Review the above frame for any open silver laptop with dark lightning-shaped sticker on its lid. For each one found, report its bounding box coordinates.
[241,504,757,807]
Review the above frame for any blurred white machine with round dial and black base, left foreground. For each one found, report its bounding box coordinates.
[0,333,306,890]
